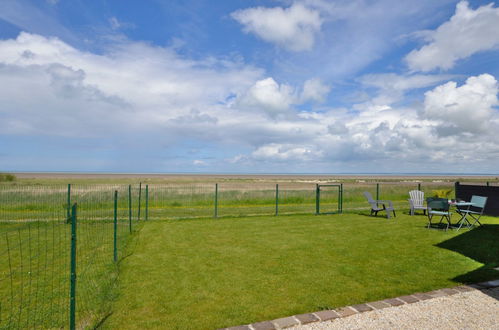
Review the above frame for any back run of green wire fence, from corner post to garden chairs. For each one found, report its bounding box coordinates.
[146,180,453,219]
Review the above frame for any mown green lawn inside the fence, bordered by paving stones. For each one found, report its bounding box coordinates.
[103,214,499,329]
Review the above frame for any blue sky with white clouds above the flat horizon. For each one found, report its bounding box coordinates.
[0,0,499,174]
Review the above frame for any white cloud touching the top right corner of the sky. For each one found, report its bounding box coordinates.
[405,1,499,71]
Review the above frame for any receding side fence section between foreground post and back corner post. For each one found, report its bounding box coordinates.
[71,184,142,327]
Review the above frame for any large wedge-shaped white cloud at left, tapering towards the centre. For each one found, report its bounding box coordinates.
[0,33,261,136]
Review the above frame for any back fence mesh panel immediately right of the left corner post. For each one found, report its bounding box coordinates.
[147,184,215,220]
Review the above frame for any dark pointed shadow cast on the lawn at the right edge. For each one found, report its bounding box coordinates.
[436,224,499,300]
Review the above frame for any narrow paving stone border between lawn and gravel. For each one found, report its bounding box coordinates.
[220,279,499,330]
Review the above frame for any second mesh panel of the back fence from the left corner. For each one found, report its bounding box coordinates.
[217,182,276,216]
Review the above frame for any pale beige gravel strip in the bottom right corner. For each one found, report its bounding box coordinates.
[288,287,499,330]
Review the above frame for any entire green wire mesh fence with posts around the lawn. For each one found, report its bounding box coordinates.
[0,180,460,329]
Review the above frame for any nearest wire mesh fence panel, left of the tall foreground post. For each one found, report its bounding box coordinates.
[0,219,69,329]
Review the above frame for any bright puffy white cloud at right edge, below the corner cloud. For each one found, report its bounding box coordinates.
[424,74,499,134]
